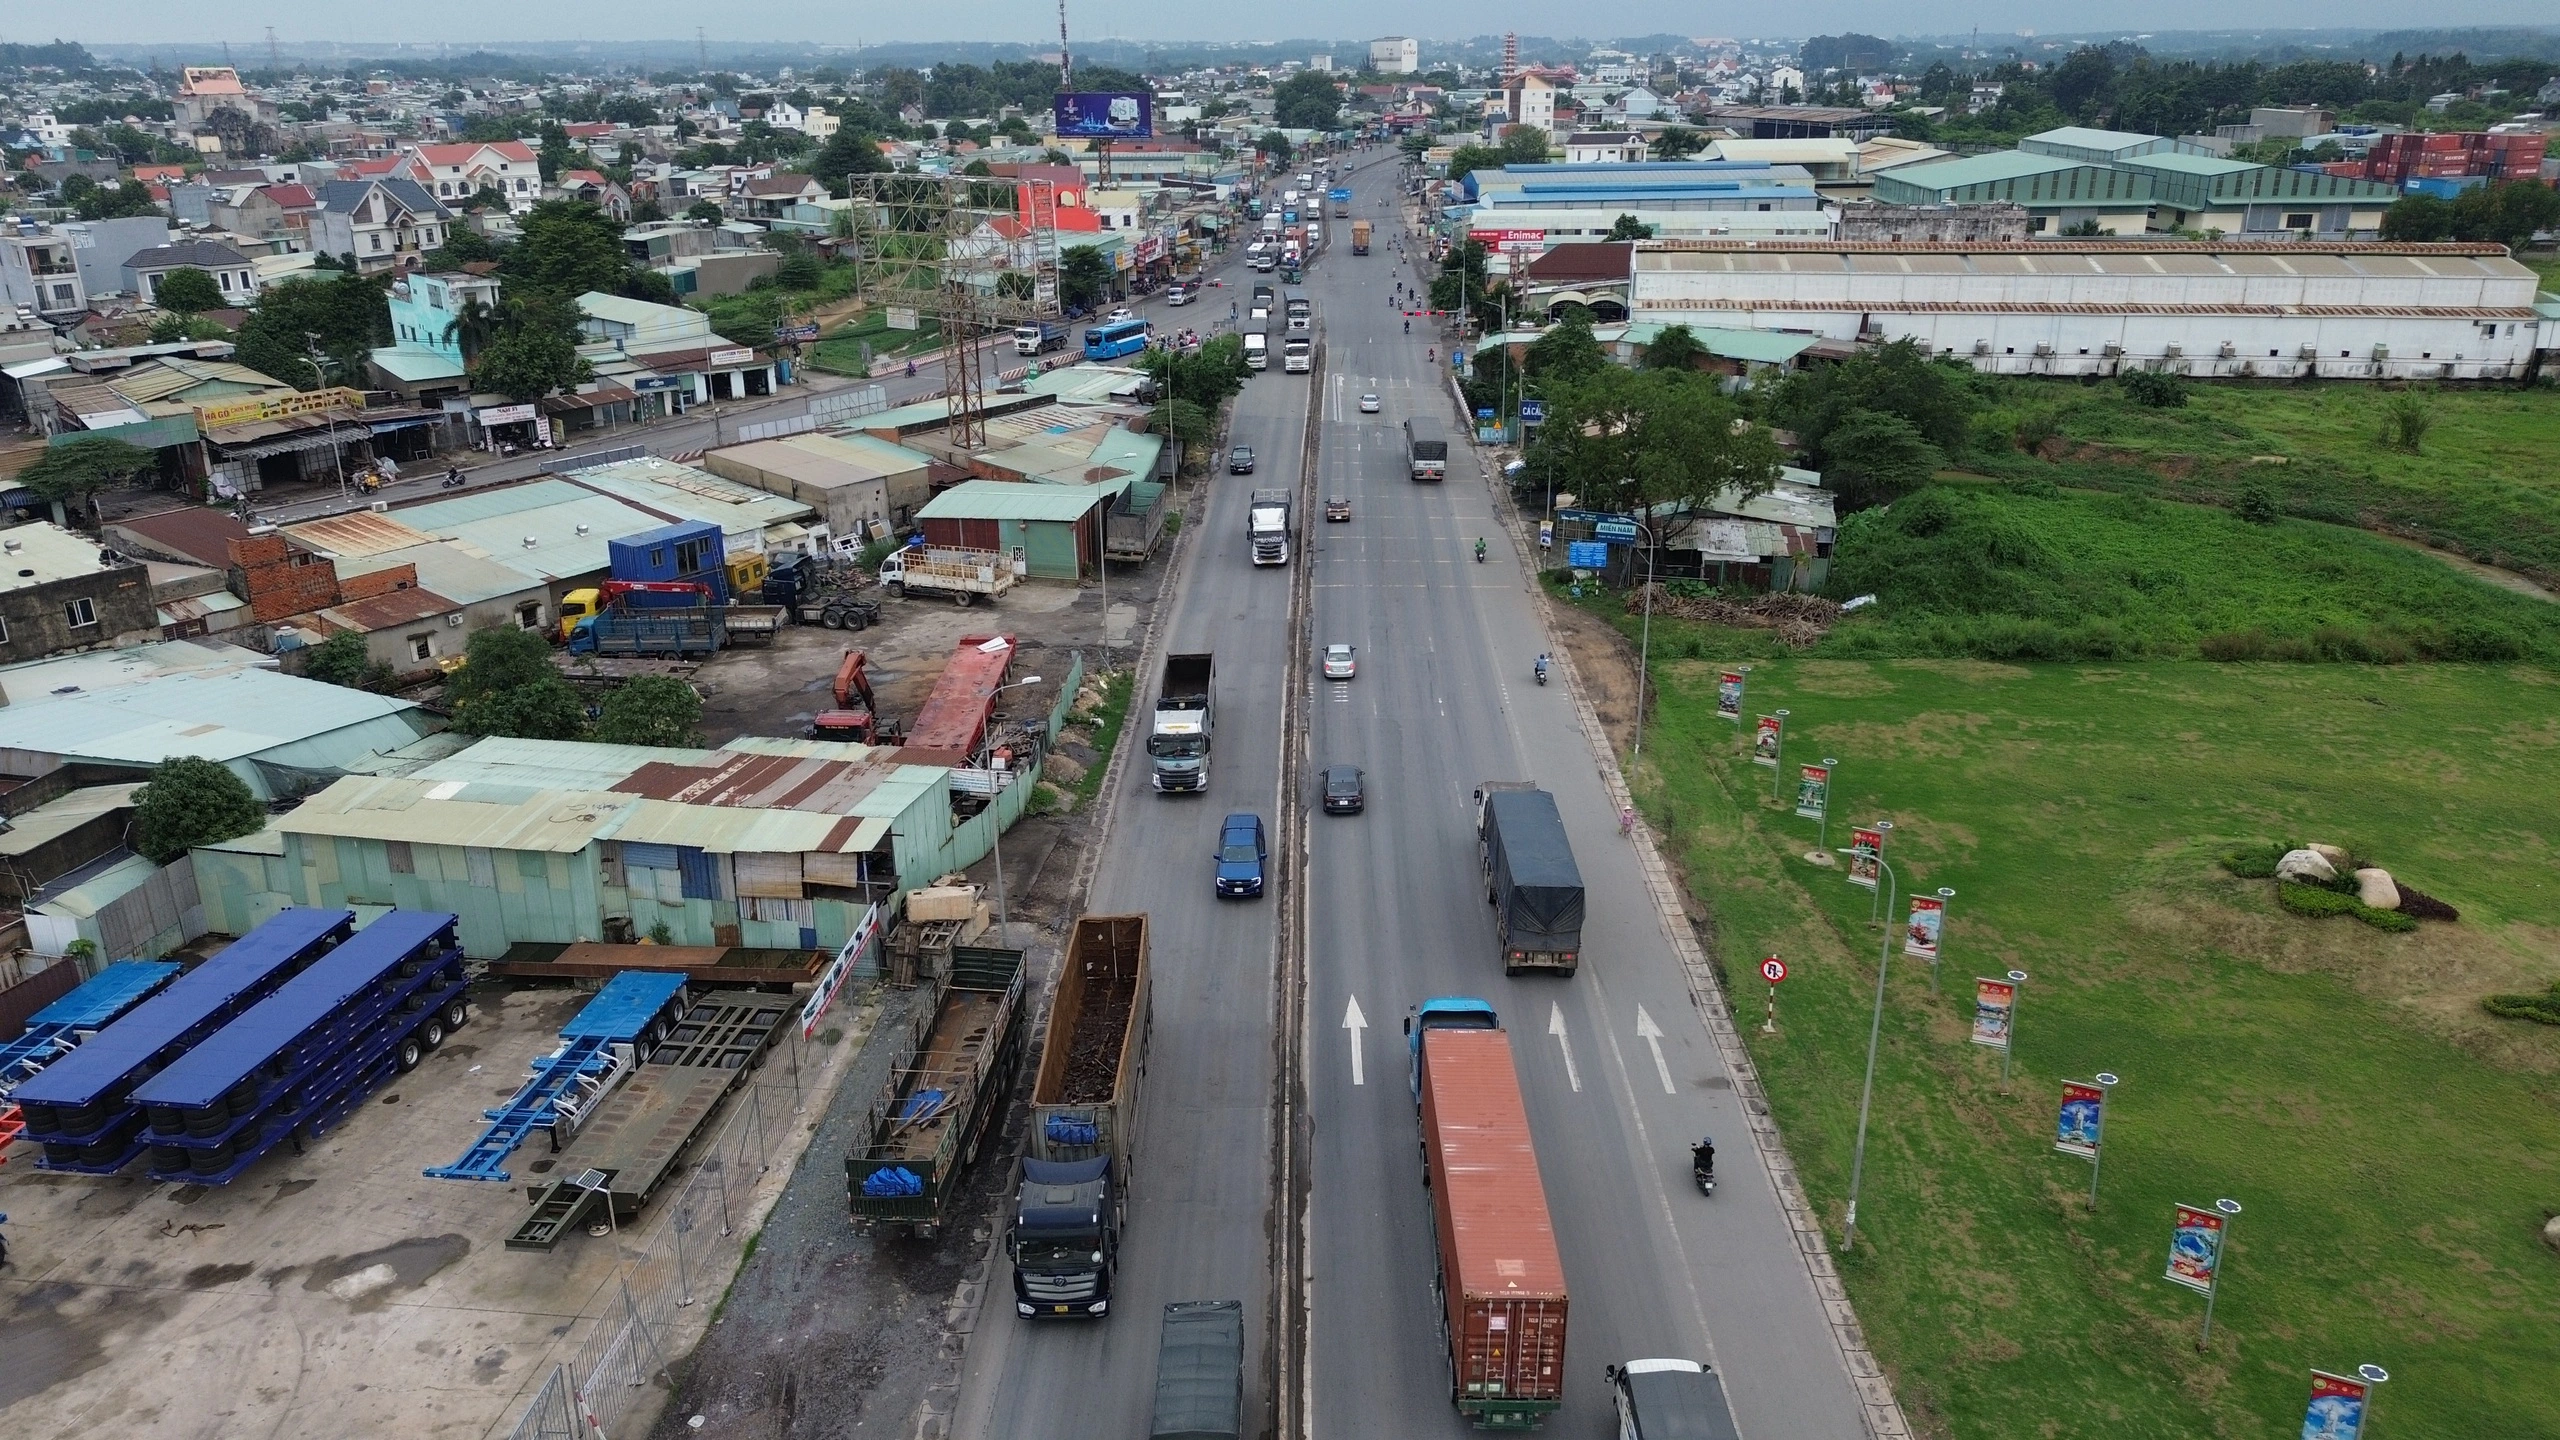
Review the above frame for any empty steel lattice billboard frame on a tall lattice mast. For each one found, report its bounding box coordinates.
[852,174,1057,451]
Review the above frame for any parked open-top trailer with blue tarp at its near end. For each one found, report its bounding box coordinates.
[845,945,1021,1240]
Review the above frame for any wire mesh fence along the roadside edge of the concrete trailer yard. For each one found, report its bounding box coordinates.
[492,1017,860,1440]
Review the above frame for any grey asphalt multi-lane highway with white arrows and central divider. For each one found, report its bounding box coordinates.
[955,156,1866,1440]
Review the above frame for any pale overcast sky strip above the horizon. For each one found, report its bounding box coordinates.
[49,0,2555,59]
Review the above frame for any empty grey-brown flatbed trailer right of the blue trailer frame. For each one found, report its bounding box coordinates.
[507,989,794,1250]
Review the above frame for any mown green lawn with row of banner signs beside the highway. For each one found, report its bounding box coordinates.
[1638,655,2560,1440]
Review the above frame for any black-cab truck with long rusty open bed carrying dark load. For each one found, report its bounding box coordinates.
[1006,915,1155,1320]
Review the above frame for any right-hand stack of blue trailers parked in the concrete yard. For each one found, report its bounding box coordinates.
[133,910,466,1184]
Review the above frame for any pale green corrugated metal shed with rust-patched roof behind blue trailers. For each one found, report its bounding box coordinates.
[195,738,1032,958]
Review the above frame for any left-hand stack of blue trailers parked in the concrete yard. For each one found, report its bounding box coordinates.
[13,910,356,1176]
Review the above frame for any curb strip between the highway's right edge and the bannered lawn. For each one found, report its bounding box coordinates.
[1487,497,1912,1440]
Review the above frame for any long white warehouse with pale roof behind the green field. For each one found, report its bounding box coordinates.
[1631,241,2555,379]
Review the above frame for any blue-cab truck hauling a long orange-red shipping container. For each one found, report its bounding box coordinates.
[1405,997,1567,1430]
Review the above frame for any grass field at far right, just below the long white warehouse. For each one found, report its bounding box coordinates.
[1976,379,2560,582]
